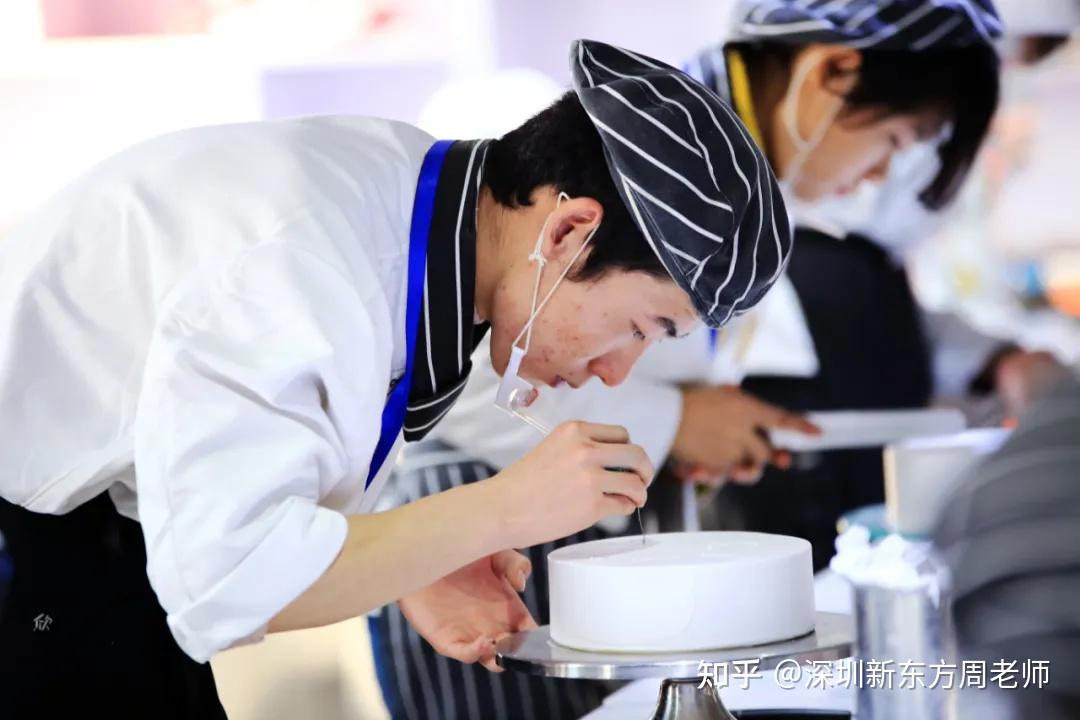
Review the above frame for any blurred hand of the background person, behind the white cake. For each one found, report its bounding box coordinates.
[672,385,821,486]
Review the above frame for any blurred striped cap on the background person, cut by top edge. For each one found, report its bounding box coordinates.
[728,0,1001,50]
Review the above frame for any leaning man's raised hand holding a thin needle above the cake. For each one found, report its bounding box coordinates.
[484,422,653,547]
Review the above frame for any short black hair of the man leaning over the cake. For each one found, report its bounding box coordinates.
[484,91,670,281]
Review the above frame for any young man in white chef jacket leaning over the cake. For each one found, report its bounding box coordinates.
[0,41,791,719]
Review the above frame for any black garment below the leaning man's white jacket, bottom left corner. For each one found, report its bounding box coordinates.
[0,493,227,720]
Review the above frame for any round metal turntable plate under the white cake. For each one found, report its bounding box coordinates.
[496,612,854,681]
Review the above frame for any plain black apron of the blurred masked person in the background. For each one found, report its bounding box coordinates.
[705,228,933,570]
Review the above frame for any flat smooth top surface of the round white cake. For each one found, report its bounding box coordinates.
[548,532,810,567]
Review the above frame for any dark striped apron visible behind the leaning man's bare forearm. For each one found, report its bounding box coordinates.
[368,440,612,720]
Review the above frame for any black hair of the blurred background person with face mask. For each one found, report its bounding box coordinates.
[731,42,1000,209]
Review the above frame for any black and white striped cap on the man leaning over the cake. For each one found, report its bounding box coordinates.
[570,40,792,327]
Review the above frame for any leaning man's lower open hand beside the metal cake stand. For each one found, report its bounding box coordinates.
[399,551,537,673]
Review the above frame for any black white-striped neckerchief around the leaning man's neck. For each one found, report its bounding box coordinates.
[404,140,488,441]
